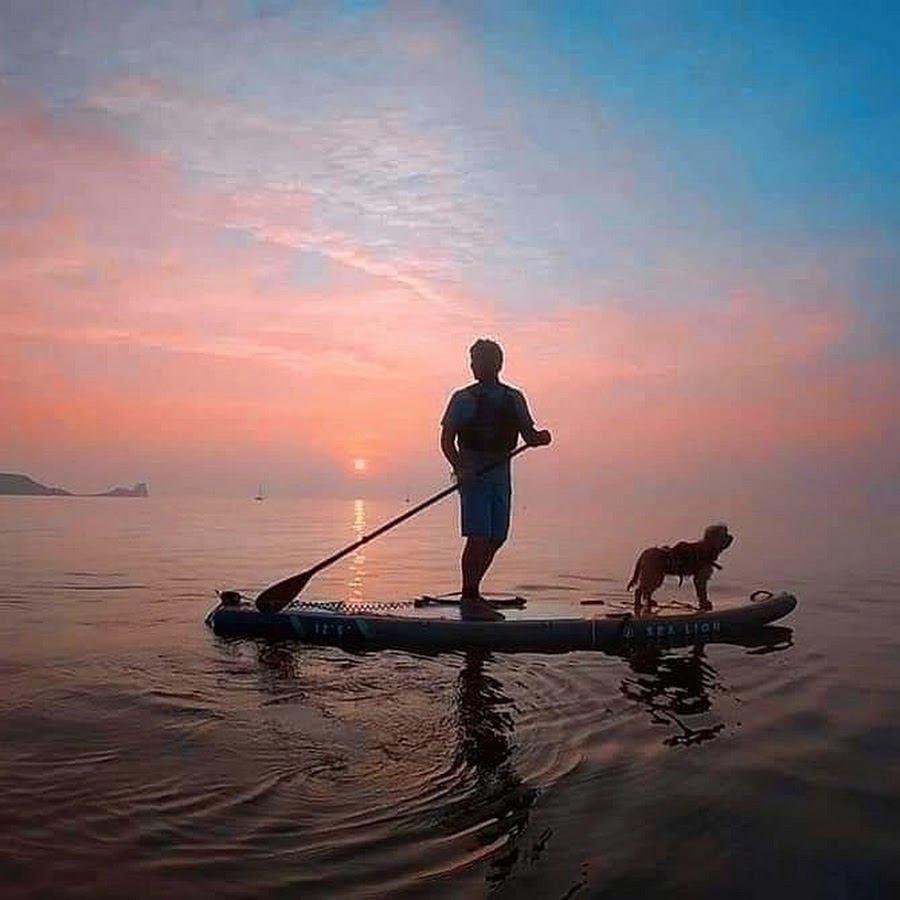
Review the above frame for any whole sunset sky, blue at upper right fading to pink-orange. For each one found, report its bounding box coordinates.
[0,0,900,521]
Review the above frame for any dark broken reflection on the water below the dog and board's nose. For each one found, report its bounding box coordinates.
[620,625,793,747]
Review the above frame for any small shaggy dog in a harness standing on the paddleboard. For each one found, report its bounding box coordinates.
[625,522,734,616]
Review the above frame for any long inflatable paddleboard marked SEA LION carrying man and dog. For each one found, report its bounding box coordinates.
[206,591,797,652]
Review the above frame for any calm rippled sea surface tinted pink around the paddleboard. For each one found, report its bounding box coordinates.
[0,497,900,900]
